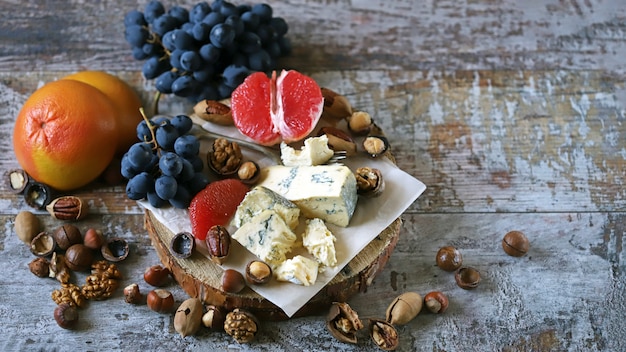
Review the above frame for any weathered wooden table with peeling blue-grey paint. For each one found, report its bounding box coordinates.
[0,0,626,351]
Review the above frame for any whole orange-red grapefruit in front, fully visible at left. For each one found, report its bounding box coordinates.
[13,80,118,190]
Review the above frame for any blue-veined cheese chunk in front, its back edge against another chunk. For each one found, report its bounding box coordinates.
[232,210,296,267]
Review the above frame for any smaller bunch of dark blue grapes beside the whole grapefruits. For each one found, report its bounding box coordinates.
[121,115,209,209]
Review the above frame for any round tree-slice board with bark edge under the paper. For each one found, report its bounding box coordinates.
[145,210,402,320]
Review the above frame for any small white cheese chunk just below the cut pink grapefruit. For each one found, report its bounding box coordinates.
[280,135,334,166]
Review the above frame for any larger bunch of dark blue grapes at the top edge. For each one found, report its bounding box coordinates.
[124,0,291,102]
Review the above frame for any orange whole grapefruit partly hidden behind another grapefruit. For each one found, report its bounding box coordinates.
[62,71,142,156]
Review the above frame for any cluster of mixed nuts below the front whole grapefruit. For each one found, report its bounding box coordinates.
[14,206,128,329]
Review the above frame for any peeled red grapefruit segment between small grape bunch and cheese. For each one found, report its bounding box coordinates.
[189,178,250,241]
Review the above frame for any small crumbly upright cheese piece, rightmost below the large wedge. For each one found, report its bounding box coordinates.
[302,218,337,267]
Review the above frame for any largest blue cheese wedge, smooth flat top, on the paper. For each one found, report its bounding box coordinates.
[259,165,357,227]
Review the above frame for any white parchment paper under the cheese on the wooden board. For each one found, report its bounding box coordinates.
[139,119,426,317]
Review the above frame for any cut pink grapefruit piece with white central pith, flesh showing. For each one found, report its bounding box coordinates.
[231,70,324,145]
